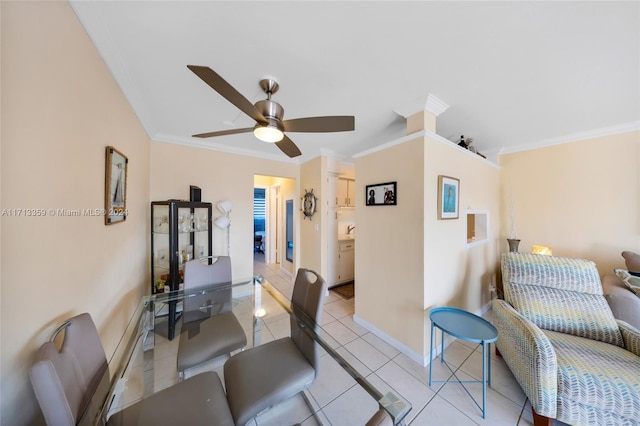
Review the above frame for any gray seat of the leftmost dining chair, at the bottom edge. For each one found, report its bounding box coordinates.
[107,372,234,426]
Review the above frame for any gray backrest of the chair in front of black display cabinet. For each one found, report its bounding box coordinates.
[183,256,232,323]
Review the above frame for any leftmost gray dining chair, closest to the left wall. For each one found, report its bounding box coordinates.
[29,313,234,426]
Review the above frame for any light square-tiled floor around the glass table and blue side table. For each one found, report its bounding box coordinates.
[249,261,562,426]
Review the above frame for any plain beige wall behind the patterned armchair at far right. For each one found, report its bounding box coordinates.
[499,131,640,274]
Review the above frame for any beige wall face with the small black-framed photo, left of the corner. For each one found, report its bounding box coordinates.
[355,137,425,354]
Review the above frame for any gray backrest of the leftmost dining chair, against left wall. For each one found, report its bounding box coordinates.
[29,313,109,425]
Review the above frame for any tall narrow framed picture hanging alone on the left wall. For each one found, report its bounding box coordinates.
[104,146,129,225]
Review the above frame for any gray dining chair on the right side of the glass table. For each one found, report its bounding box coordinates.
[224,268,327,425]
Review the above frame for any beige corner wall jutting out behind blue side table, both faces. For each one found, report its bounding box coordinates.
[355,132,500,361]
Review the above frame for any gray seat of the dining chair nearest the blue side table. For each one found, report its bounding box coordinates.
[224,337,315,425]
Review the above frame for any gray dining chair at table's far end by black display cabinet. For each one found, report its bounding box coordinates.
[177,256,247,380]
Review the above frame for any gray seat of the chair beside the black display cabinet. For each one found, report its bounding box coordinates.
[178,312,247,371]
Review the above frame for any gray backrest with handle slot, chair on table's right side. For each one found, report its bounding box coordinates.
[291,268,327,376]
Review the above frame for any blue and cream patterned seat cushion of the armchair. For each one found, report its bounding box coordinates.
[544,331,640,424]
